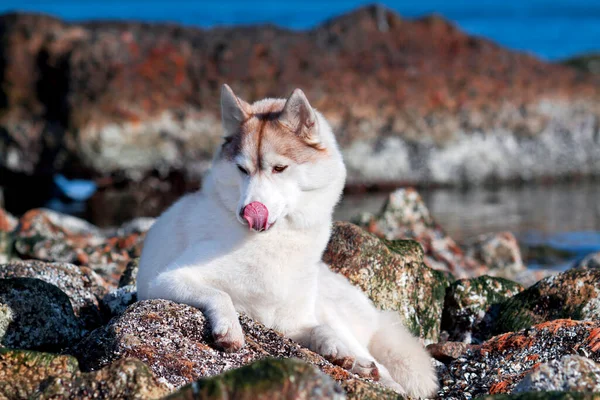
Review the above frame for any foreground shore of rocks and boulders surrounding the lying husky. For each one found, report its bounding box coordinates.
[0,189,600,399]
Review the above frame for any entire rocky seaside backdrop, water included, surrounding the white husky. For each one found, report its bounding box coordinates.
[0,0,600,399]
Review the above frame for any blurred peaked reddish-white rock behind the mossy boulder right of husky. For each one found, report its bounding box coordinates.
[355,188,487,278]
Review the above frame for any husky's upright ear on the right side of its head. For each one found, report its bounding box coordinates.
[279,89,320,146]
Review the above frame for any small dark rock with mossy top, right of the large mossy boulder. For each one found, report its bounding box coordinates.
[441,275,523,343]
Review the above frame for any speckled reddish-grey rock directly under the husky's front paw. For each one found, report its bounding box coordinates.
[69,300,356,388]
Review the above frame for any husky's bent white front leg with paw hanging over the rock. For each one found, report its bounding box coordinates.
[150,268,244,351]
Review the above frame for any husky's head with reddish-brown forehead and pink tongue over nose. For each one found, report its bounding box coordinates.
[212,85,346,232]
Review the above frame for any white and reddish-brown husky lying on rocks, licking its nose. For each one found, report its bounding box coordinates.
[137,85,437,396]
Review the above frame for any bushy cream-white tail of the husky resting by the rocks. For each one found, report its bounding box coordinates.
[369,311,438,397]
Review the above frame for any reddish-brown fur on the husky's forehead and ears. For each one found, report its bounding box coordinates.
[221,85,325,168]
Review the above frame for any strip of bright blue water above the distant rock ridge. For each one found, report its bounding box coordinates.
[0,0,600,60]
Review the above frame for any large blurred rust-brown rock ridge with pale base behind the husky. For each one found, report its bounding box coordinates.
[0,6,600,222]
